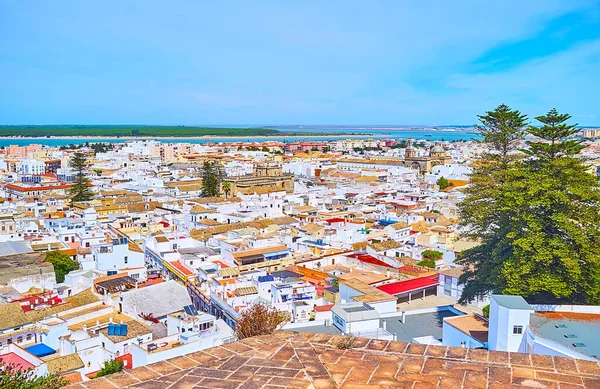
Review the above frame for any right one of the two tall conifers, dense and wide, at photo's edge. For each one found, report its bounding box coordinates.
[503,109,600,305]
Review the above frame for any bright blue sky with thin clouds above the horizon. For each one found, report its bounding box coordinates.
[0,0,600,125]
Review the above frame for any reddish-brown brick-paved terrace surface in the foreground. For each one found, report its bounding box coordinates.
[69,332,600,389]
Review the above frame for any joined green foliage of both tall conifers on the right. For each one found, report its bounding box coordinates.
[457,106,600,305]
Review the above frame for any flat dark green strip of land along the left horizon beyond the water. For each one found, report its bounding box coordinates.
[0,125,280,137]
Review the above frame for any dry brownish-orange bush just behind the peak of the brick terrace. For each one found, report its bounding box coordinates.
[235,304,288,339]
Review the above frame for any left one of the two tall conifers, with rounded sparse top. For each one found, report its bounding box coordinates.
[457,104,528,302]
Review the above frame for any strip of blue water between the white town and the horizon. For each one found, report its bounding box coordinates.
[0,126,481,147]
